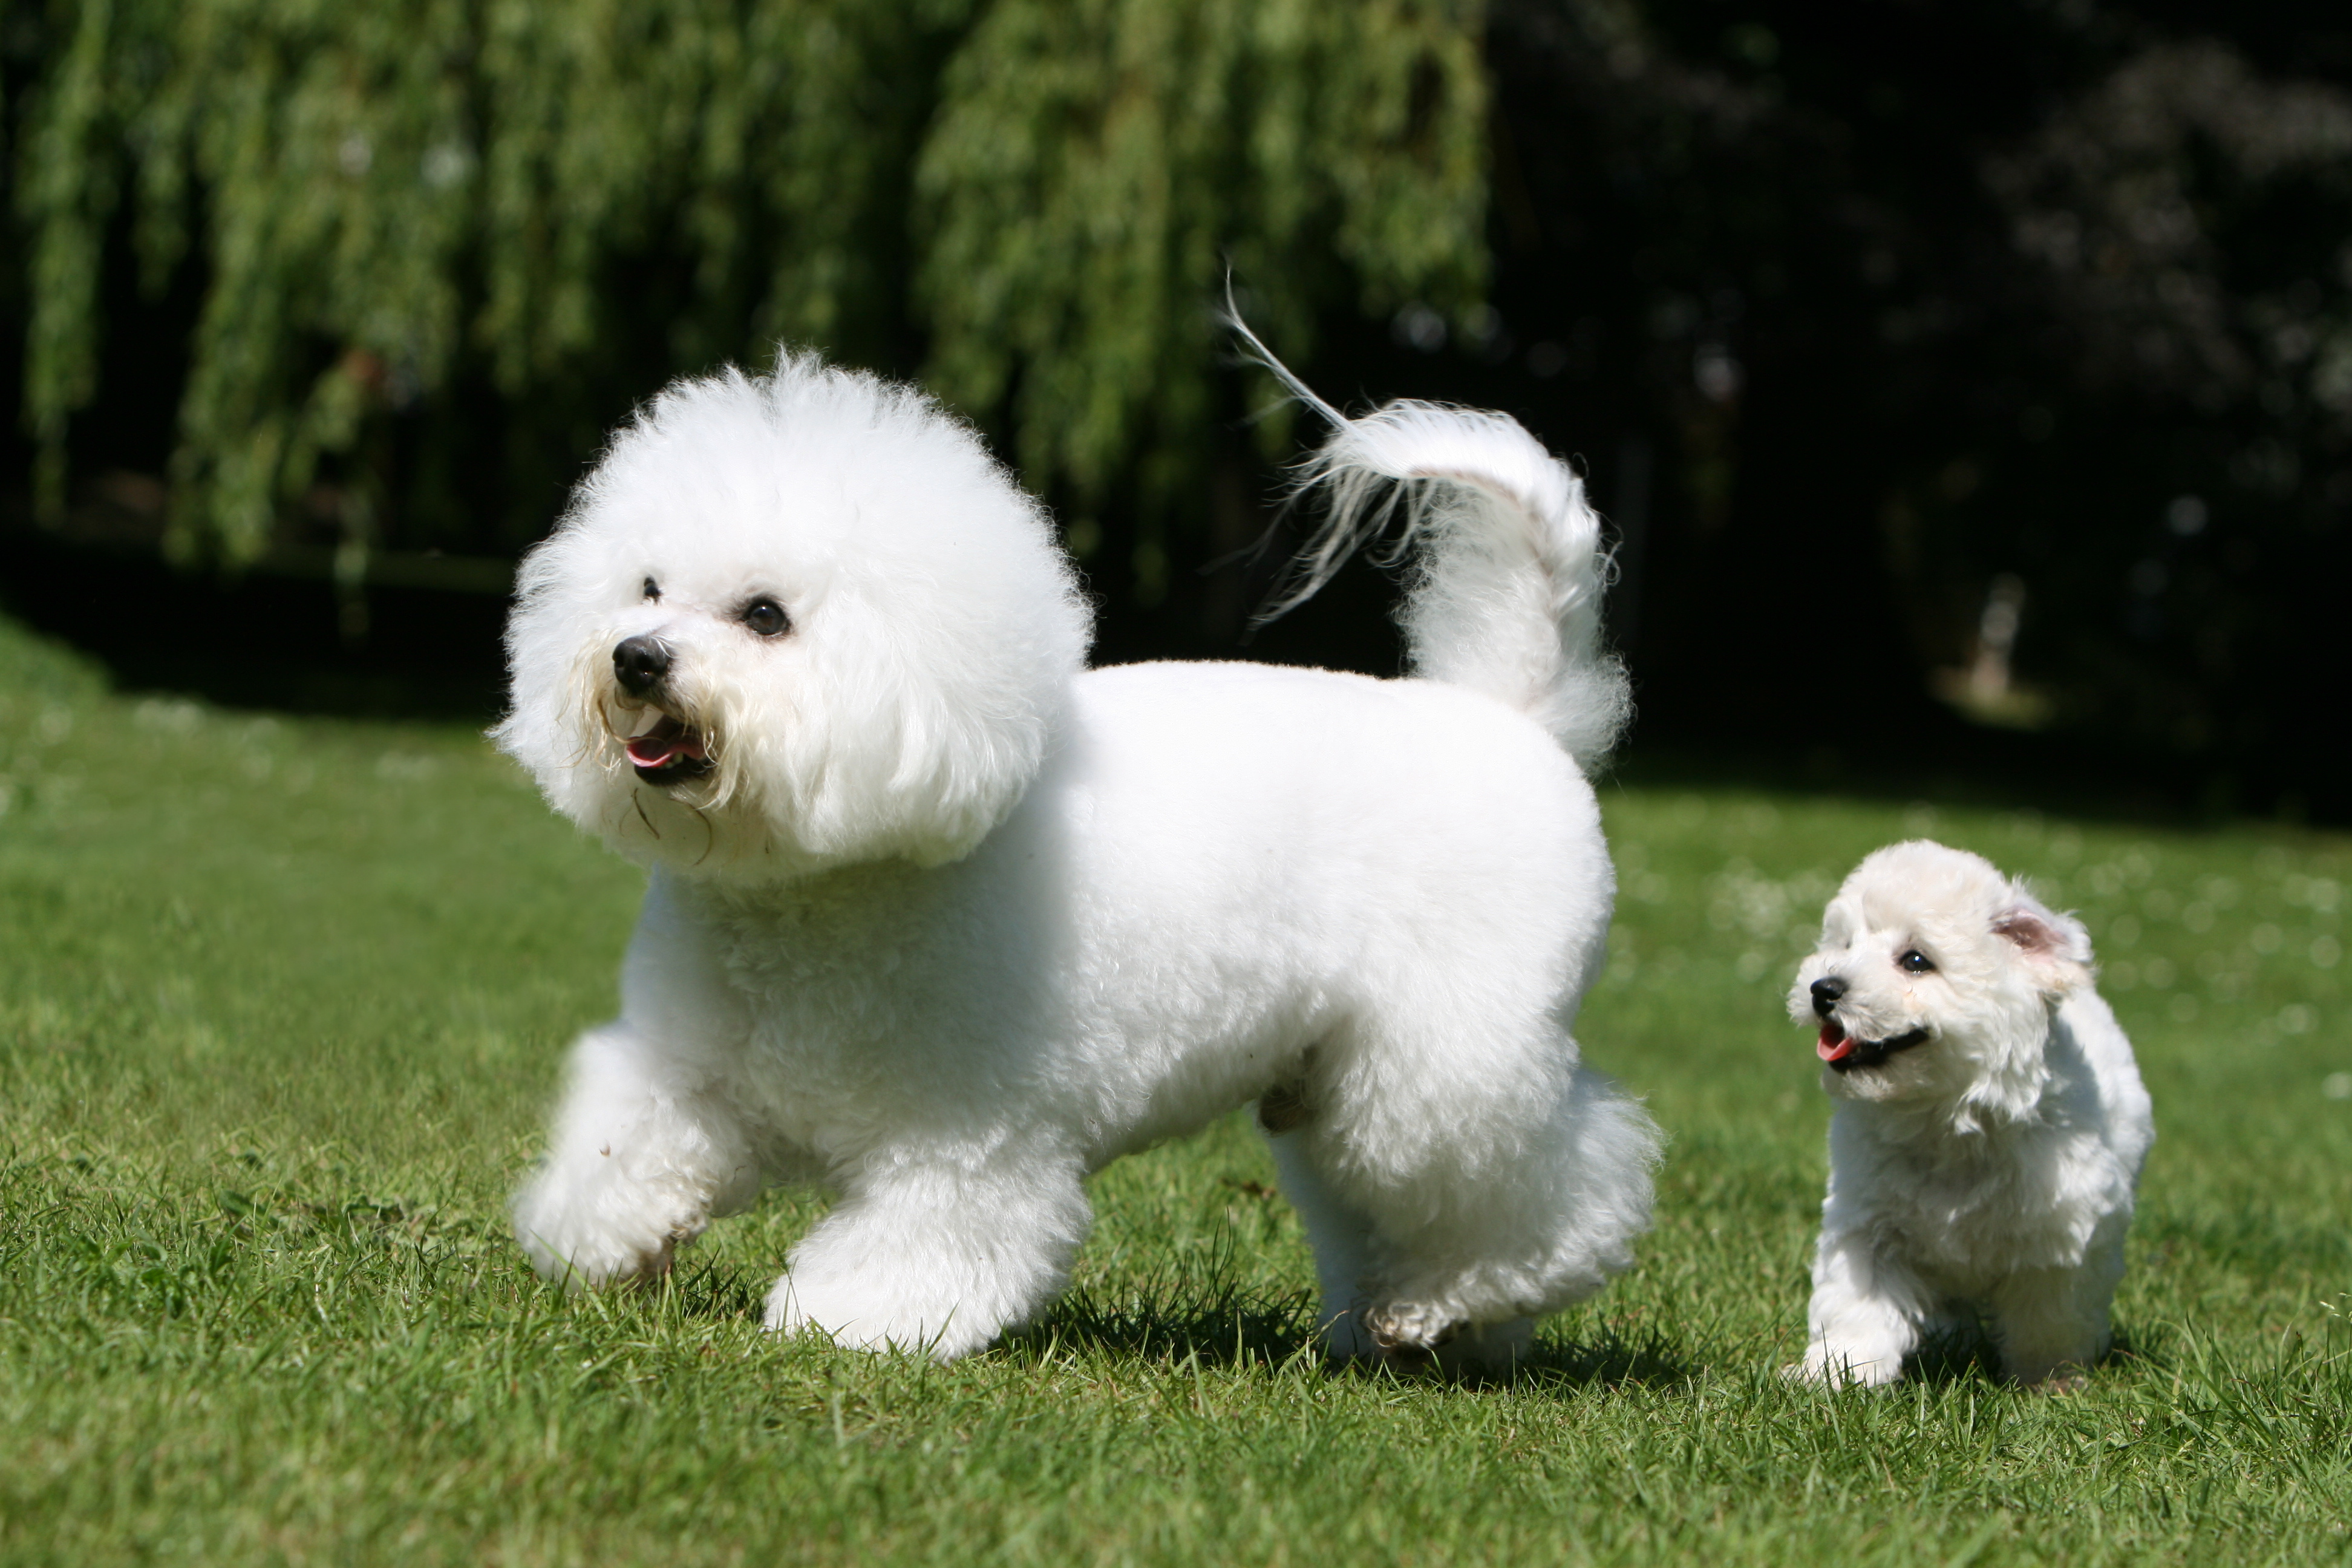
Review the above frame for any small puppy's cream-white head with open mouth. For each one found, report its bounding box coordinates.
[1788,839,2091,1122]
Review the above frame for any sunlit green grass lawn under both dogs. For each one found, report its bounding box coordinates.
[0,623,2352,1566]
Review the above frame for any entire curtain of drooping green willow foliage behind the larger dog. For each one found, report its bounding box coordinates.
[7,0,1486,564]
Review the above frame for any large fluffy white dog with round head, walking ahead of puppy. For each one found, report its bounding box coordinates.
[494,345,1656,1361]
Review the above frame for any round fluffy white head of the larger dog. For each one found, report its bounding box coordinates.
[492,355,1091,879]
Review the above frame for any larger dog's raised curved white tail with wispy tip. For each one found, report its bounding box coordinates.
[1230,315,1632,774]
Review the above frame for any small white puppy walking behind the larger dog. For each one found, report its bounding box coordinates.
[1788,839,2157,1385]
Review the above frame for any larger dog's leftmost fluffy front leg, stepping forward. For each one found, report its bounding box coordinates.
[515,1022,760,1290]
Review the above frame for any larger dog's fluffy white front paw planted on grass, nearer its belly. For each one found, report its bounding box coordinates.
[766,1152,1094,1361]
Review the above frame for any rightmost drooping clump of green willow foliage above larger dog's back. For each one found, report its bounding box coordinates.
[917,0,1486,501]
